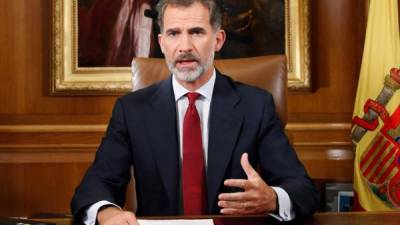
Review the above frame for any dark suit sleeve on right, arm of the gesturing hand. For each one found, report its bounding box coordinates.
[258,95,319,217]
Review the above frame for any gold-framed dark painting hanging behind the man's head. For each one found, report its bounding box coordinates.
[50,0,311,95]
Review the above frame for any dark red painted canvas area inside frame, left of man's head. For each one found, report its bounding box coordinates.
[78,0,154,67]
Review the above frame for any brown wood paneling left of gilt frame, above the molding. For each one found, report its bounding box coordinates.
[0,0,116,119]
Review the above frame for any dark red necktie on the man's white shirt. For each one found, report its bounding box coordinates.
[182,92,207,215]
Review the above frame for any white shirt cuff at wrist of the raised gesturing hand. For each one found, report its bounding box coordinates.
[269,187,295,221]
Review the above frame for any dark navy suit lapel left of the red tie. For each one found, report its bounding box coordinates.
[147,76,180,213]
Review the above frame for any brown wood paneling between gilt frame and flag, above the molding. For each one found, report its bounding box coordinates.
[288,0,365,122]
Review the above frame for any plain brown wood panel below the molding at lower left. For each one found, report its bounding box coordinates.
[0,162,89,217]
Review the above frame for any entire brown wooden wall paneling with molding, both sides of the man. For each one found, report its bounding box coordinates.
[0,0,365,216]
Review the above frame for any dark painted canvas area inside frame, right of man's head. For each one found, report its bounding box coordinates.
[219,0,285,58]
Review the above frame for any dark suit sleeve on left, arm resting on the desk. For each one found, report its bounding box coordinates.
[71,100,132,221]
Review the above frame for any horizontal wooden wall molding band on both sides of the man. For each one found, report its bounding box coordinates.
[0,123,352,163]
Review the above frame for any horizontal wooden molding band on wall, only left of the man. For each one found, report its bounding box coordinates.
[0,125,105,163]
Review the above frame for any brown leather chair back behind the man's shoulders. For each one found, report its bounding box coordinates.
[132,55,287,126]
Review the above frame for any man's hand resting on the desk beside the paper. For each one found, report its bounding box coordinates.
[97,206,139,225]
